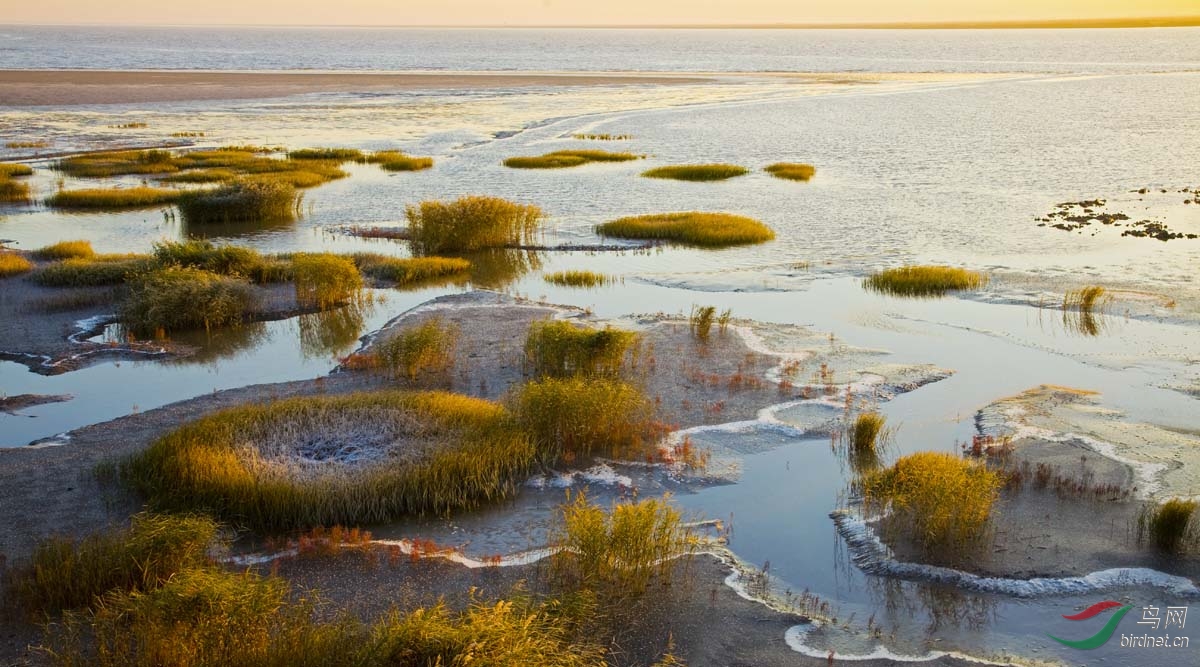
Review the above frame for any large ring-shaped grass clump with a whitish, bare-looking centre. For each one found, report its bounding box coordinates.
[121,391,535,530]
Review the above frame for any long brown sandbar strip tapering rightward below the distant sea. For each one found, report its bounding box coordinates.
[0,70,712,107]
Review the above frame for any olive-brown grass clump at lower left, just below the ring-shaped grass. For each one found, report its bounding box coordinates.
[12,512,218,614]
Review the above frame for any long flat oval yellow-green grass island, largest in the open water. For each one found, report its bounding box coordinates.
[595,211,775,247]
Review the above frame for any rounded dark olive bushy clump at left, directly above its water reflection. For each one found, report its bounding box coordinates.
[118,266,256,336]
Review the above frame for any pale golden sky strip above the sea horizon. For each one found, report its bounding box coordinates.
[0,0,1200,25]
